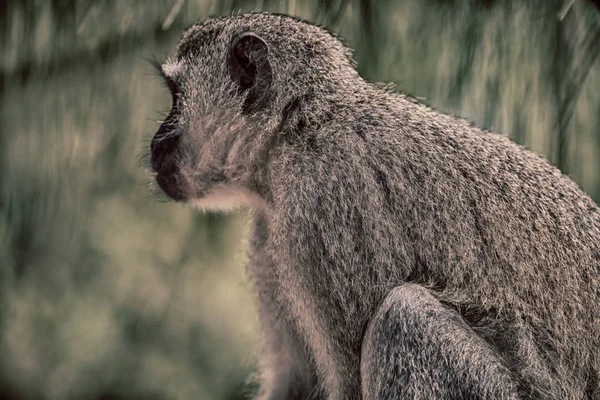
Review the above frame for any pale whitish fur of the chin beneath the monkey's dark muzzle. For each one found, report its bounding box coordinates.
[188,185,267,212]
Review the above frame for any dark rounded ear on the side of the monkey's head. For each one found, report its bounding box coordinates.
[229,32,273,112]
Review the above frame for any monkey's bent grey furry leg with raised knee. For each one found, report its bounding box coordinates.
[361,284,520,400]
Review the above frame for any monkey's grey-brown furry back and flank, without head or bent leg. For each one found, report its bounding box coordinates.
[269,88,600,398]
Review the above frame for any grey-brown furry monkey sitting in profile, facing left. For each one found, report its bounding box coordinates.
[150,13,600,400]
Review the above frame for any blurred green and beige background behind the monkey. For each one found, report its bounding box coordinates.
[0,0,600,400]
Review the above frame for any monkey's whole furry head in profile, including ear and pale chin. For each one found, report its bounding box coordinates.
[151,14,358,208]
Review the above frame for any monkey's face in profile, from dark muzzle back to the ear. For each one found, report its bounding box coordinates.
[151,21,273,206]
